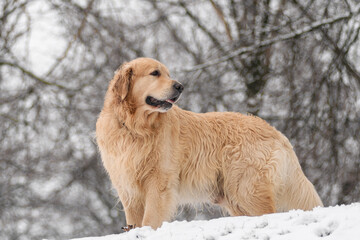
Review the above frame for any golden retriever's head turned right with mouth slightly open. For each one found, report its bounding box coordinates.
[112,58,184,112]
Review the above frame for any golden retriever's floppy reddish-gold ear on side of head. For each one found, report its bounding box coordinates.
[113,63,133,102]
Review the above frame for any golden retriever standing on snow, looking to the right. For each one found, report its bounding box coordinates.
[96,58,323,229]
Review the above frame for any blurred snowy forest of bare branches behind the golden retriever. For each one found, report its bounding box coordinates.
[0,0,360,239]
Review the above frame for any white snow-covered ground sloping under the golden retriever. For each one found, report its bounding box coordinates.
[74,203,360,240]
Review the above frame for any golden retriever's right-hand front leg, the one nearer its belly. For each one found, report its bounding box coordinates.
[142,181,176,229]
